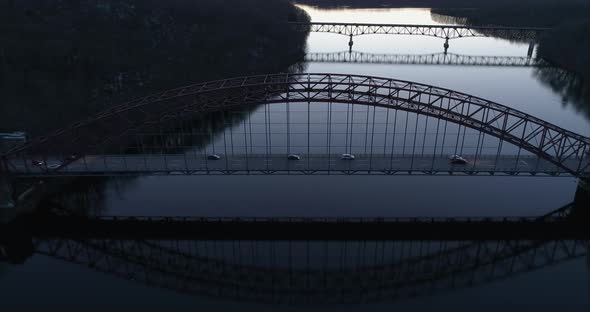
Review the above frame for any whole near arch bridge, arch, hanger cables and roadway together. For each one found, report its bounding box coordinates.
[3,74,590,178]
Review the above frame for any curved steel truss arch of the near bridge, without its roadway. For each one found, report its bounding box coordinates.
[2,73,590,178]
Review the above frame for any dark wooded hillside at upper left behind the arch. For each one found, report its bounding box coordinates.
[0,0,309,135]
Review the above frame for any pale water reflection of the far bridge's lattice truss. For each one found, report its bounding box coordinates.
[305,51,551,67]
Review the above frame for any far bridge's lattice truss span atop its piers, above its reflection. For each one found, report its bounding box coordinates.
[290,22,548,40]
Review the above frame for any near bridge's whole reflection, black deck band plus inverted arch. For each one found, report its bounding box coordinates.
[0,192,590,304]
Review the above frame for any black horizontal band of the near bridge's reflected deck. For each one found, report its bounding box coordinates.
[5,216,590,240]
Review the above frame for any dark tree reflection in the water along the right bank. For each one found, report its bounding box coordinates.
[534,67,590,120]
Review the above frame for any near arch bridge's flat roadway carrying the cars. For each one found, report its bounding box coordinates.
[3,154,580,176]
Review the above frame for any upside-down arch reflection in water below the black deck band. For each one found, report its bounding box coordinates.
[35,239,589,303]
